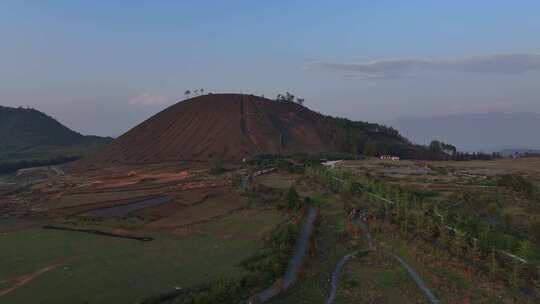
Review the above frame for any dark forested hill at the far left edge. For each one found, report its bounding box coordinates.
[0,106,111,149]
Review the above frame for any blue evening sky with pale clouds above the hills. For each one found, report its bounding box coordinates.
[0,0,540,136]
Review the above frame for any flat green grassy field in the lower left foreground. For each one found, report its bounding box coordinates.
[0,229,257,303]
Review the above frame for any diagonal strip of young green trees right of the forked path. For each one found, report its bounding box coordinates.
[308,163,540,300]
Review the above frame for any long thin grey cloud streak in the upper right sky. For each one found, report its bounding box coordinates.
[308,53,540,79]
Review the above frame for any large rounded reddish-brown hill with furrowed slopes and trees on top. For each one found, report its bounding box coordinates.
[87,94,430,164]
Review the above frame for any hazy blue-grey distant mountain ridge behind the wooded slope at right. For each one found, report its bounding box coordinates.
[387,113,540,152]
